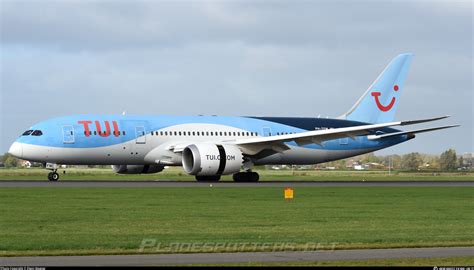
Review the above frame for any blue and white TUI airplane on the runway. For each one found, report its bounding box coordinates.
[9,53,459,182]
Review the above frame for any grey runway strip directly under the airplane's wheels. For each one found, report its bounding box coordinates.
[0,180,474,188]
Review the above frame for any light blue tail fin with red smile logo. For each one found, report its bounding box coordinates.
[340,53,413,123]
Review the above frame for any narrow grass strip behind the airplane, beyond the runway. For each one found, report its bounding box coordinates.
[0,167,474,181]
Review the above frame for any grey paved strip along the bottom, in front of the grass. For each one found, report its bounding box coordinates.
[0,247,474,266]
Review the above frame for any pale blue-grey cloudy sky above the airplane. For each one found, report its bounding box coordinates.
[0,0,474,154]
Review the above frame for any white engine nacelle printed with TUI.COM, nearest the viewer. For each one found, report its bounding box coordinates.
[183,143,244,175]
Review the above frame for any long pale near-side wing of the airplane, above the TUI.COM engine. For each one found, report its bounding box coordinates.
[235,116,449,155]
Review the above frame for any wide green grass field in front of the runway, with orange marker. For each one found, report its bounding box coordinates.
[0,187,474,256]
